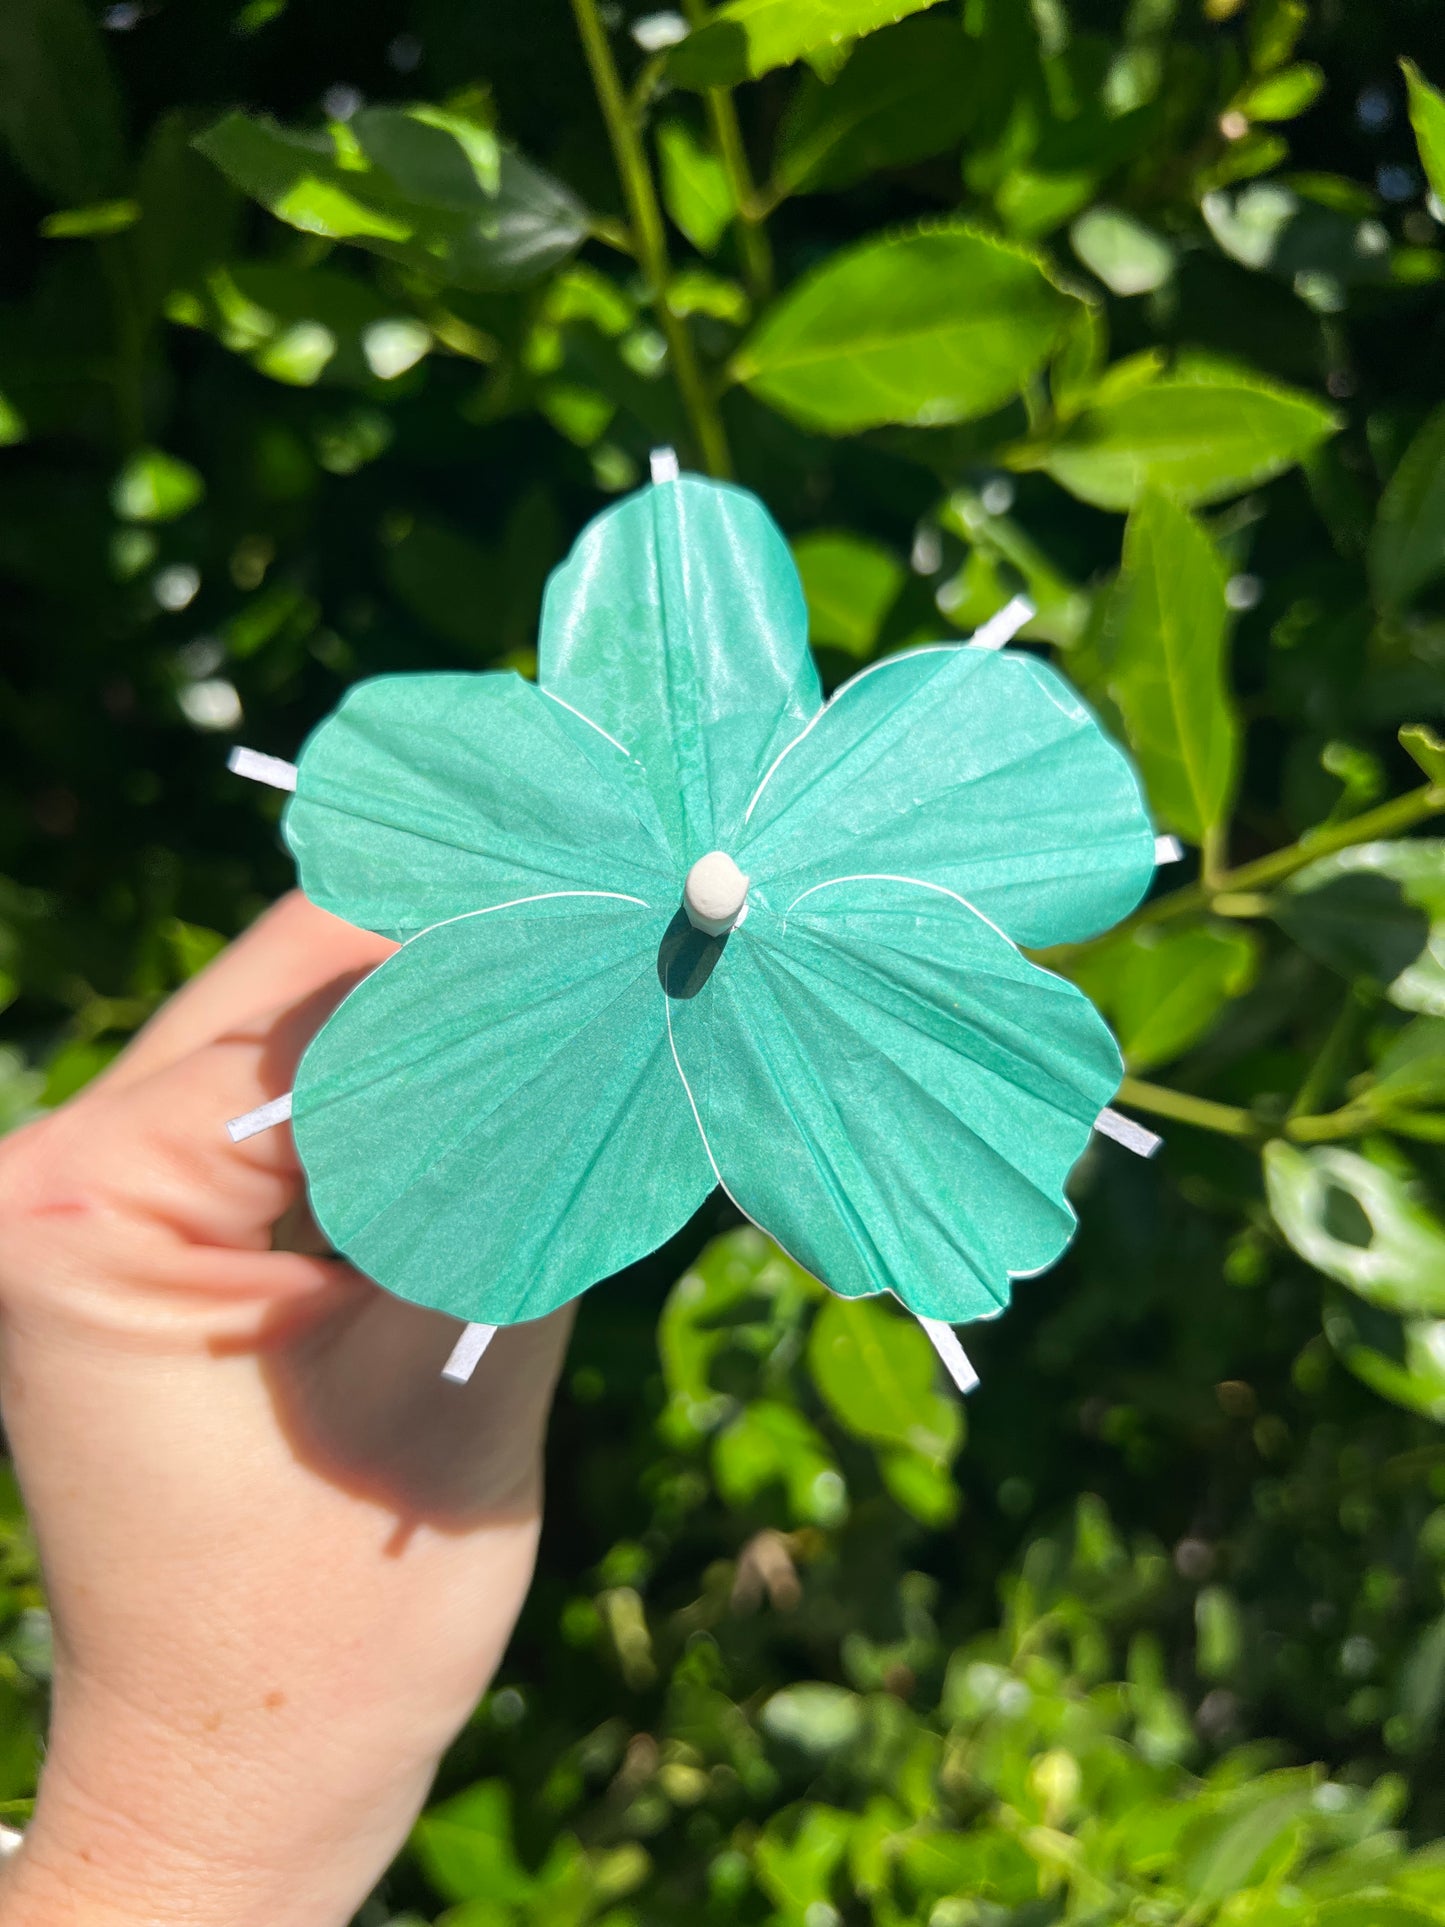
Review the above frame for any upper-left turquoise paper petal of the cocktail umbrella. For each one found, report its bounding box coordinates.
[283,674,676,938]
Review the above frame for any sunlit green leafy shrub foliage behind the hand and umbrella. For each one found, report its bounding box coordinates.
[0,0,1445,1927]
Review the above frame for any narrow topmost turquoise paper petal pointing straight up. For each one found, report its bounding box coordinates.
[538,476,821,869]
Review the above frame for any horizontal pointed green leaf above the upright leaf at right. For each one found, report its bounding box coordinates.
[1015,360,1339,509]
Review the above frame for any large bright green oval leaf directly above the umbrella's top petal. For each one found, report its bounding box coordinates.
[732,225,1075,436]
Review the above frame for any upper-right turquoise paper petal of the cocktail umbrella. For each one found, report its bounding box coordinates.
[732,647,1154,946]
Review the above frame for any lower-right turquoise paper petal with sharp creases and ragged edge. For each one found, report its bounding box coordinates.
[669,877,1123,1324]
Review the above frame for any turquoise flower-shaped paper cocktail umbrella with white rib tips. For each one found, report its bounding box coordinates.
[231,453,1179,1384]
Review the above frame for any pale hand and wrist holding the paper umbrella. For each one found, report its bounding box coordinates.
[0,896,566,1927]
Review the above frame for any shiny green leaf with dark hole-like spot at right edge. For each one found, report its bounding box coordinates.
[1264,1139,1445,1316]
